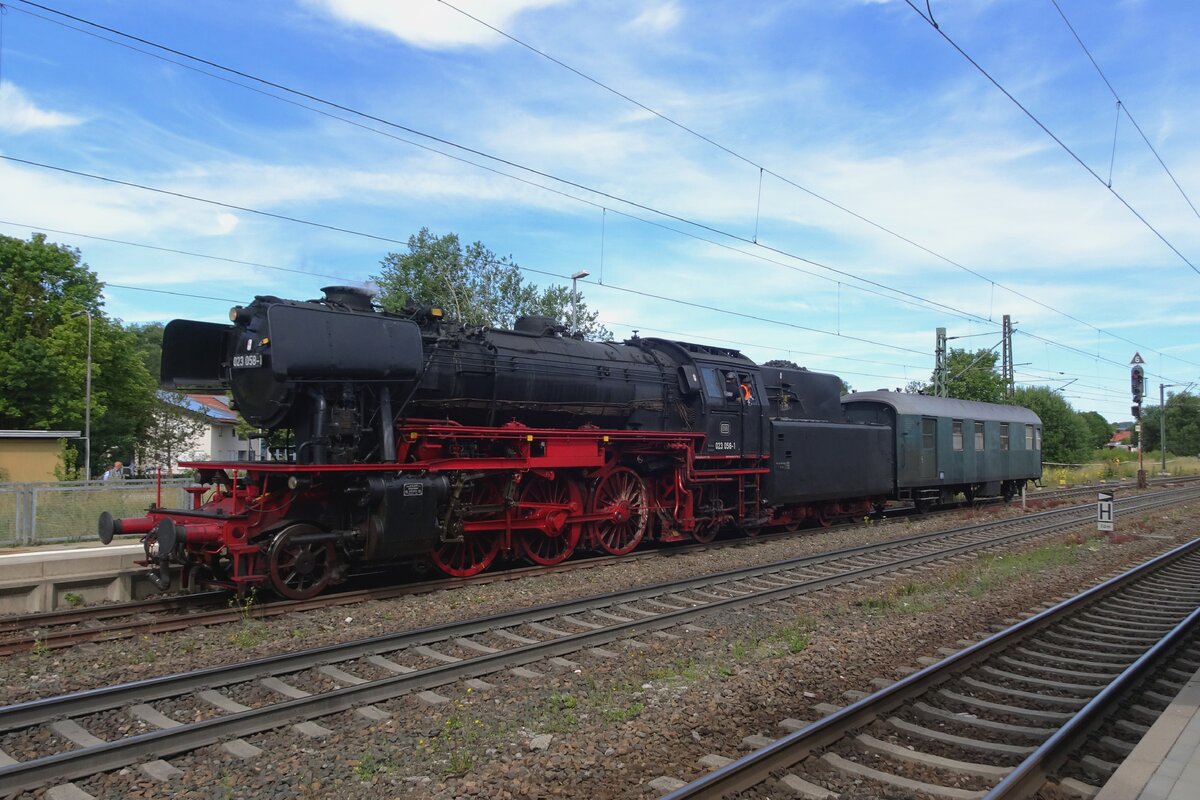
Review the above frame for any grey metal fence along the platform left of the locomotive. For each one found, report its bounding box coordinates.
[0,479,192,547]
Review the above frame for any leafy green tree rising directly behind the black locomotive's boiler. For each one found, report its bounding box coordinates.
[372,228,612,339]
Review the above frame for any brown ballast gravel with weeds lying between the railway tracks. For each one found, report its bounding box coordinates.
[0,491,1195,800]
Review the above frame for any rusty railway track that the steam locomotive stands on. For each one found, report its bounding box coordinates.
[0,479,1161,656]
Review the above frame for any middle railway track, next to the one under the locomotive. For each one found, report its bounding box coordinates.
[0,489,1200,794]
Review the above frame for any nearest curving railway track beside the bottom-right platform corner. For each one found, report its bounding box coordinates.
[665,527,1200,800]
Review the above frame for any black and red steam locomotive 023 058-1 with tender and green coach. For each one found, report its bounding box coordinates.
[100,287,1040,599]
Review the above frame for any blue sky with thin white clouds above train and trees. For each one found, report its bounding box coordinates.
[0,0,1200,421]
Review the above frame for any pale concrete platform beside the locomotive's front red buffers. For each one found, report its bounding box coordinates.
[0,541,154,614]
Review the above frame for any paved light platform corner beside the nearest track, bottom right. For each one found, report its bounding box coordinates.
[1096,670,1200,800]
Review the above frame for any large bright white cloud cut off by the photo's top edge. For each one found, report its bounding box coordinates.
[308,0,562,50]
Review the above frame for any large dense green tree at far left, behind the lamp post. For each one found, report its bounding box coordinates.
[0,234,154,479]
